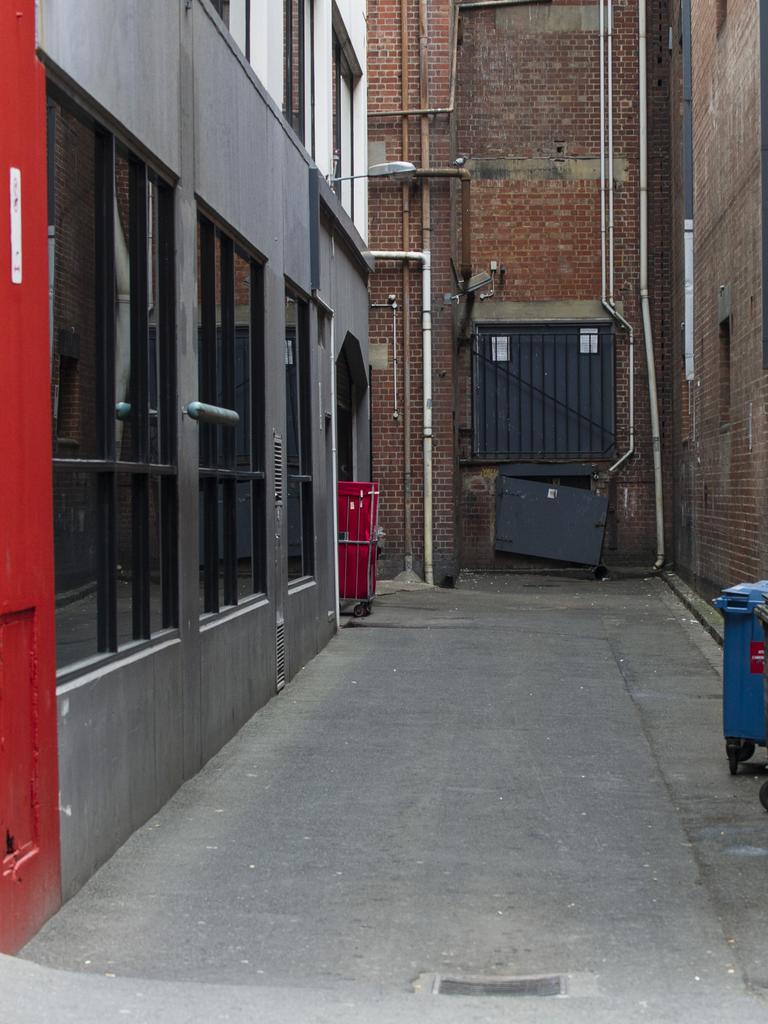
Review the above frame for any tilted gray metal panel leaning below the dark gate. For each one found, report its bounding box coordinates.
[496,476,608,565]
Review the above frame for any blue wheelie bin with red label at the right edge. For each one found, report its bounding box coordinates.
[713,580,768,775]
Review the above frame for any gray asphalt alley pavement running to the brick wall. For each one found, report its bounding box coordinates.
[9,575,768,1024]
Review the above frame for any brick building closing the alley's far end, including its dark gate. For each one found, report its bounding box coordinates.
[369,0,672,583]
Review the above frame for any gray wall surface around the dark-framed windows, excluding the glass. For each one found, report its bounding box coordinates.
[40,0,369,897]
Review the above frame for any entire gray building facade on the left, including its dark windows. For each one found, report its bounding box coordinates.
[38,0,370,898]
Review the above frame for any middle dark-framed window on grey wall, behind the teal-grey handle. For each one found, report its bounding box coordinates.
[198,215,266,614]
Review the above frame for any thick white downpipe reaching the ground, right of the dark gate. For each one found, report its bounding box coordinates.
[638,0,665,569]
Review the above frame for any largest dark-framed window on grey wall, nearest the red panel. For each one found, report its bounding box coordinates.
[48,96,178,669]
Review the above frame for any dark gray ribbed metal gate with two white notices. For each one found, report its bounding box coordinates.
[472,324,615,459]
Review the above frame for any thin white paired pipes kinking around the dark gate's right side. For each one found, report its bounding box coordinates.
[600,0,635,473]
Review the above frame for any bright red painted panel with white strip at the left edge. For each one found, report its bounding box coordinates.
[0,0,60,952]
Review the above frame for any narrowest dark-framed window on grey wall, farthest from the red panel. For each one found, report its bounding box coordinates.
[286,292,314,581]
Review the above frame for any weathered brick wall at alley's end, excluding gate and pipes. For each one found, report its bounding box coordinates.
[369,0,672,581]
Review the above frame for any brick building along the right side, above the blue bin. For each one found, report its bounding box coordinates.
[671,0,768,595]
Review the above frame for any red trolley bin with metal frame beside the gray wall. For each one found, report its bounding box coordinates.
[338,480,379,617]
